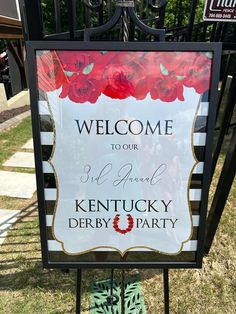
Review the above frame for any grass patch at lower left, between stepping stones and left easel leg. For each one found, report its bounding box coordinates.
[0,207,75,314]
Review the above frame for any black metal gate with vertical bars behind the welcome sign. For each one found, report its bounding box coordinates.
[18,0,236,313]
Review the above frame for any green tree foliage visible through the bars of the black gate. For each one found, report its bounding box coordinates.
[39,0,209,33]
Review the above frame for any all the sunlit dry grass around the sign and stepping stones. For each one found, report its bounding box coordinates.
[0,119,236,314]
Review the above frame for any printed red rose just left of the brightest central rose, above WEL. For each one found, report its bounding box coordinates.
[60,74,101,103]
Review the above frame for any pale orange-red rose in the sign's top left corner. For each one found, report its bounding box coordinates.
[36,51,66,92]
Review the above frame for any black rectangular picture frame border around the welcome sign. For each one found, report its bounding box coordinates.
[26,41,221,269]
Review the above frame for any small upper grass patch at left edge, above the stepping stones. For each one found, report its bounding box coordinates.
[0,117,32,167]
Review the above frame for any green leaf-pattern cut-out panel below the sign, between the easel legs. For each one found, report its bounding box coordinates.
[90,276,147,314]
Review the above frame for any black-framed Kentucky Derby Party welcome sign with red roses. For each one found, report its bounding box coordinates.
[27,42,220,268]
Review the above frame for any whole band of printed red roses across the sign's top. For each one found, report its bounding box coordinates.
[37,50,212,104]
